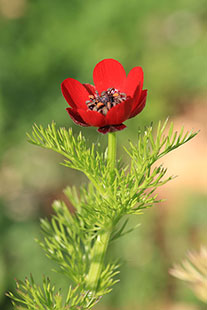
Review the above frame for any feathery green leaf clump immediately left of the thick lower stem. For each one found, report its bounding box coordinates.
[40,201,92,283]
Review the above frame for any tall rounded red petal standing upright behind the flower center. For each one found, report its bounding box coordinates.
[93,59,126,93]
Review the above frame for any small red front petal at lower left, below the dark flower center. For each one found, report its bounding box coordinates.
[78,109,106,127]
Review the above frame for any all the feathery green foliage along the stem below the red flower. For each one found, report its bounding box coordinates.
[10,121,196,310]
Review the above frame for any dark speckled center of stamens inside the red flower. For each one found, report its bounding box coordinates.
[86,88,127,115]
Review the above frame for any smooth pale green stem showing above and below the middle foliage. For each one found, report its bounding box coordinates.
[87,132,116,292]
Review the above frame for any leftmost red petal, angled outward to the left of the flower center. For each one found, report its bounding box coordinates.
[61,78,89,110]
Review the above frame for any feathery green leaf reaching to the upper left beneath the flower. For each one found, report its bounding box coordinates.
[28,122,108,195]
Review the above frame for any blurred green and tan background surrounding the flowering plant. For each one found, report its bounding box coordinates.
[0,0,207,310]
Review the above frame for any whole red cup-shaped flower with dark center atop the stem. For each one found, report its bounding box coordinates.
[61,59,147,133]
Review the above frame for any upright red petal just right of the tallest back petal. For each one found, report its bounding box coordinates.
[124,67,144,98]
